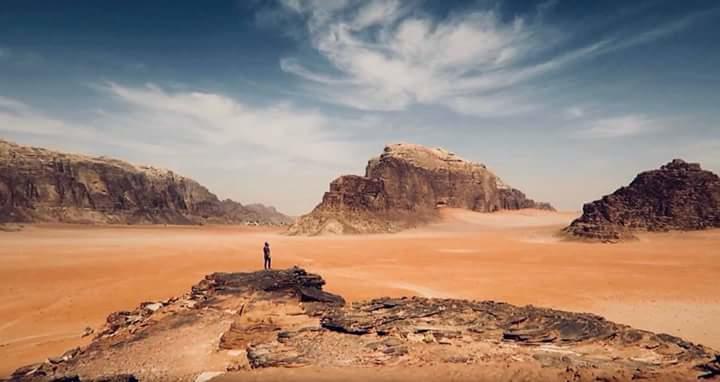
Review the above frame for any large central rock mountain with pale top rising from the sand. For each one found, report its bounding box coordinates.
[289,144,552,235]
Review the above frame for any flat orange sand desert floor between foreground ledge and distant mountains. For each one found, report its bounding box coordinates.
[0,210,720,377]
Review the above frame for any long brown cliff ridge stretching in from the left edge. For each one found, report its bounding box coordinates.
[0,140,292,224]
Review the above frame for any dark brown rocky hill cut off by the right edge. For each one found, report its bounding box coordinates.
[565,159,720,242]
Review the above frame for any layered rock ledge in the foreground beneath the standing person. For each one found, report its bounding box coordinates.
[11,267,720,381]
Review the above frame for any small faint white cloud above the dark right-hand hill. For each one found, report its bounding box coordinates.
[578,114,668,138]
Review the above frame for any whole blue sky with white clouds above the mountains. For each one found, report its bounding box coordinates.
[0,0,720,215]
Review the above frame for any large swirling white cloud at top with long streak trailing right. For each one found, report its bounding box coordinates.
[281,0,708,116]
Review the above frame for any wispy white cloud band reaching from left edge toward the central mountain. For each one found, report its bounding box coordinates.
[0,82,372,163]
